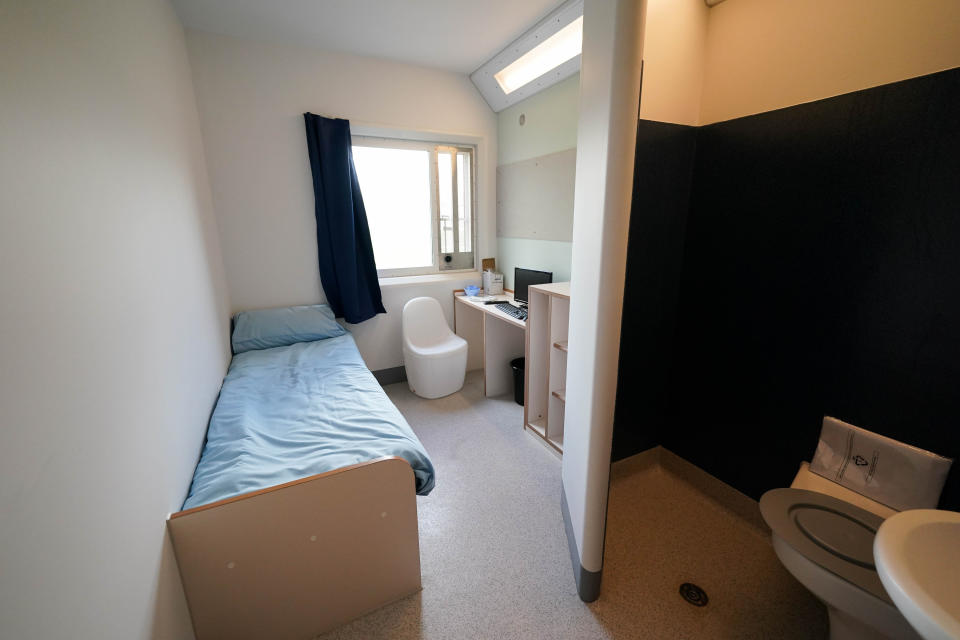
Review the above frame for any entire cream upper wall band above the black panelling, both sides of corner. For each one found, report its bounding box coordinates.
[640,0,960,125]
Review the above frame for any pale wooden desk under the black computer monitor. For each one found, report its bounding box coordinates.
[453,292,527,396]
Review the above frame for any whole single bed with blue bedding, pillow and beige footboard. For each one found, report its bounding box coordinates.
[168,306,434,640]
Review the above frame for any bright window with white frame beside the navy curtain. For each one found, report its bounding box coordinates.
[353,136,476,277]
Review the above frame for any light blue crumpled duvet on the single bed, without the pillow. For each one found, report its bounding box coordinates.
[183,334,434,509]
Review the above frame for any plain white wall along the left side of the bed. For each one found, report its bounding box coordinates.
[0,0,229,640]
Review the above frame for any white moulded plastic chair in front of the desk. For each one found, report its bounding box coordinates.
[403,298,467,398]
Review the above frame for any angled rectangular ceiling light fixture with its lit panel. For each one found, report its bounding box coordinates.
[470,0,583,112]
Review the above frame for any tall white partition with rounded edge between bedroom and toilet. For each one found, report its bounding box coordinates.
[562,0,644,601]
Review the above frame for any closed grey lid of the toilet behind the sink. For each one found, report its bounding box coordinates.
[760,489,891,602]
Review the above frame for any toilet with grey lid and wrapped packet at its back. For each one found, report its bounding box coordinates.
[760,418,952,640]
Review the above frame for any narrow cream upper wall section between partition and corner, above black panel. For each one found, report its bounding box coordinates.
[640,0,708,125]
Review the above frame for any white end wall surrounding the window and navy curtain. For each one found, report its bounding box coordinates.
[187,31,497,370]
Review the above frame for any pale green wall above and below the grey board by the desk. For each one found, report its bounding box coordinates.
[497,73,580,289]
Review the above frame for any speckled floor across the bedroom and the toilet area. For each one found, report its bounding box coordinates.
[320,372,827,640]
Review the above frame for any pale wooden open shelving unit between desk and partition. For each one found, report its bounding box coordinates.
[523,282,570,454]
